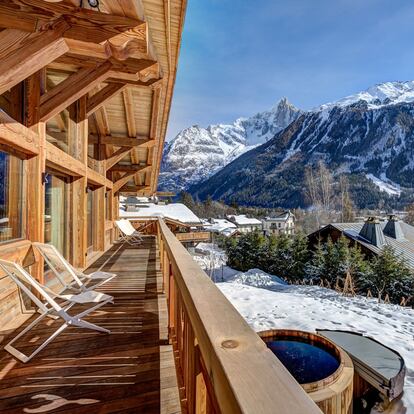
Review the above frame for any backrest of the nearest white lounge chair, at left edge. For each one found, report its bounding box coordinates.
[0,260,62,312]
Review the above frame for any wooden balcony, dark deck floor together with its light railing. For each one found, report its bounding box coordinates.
[0,220,320,414]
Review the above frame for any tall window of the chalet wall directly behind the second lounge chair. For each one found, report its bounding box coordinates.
[44,173,69,258]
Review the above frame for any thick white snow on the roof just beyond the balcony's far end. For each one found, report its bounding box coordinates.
[119,203,201,224]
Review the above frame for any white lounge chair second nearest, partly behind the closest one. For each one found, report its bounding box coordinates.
[32,242,116,292]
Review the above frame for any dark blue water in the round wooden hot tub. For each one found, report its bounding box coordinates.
[267,339,339,384]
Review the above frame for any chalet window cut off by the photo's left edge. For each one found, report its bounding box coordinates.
[0,151,23,242]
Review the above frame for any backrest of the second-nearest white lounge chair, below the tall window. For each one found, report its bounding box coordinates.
[32,242,82,288]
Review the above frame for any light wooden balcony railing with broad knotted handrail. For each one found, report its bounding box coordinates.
[157,219,320,414]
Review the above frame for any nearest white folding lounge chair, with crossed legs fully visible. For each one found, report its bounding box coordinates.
[0,260,113,362]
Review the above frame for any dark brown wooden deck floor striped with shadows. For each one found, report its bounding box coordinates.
[0,237,181,414]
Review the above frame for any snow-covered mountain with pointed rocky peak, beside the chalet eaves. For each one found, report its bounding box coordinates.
[159,98,302,191]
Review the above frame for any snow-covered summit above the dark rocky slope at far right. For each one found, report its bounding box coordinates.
[315,81,414,111]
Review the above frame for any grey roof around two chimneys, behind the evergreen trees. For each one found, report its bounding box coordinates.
[313,222,414,269]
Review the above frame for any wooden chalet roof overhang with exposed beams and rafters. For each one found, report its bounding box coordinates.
[9,0,186,195]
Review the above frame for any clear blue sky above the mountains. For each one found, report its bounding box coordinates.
[167,0,414,139]
